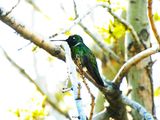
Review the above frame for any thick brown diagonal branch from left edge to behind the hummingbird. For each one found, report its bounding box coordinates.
[0,8,65,61]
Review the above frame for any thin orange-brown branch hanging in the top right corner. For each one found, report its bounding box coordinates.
[148,0,160,45]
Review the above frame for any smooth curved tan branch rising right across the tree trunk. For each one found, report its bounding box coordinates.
[113,46,160,85]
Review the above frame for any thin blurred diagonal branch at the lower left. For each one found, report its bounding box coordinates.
[1,47,70,119]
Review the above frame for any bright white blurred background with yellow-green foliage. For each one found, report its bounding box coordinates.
[0,0,160,120]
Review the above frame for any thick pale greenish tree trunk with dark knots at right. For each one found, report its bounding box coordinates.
[125,0,154,120]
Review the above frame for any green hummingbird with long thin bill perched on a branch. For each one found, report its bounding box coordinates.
[53,35,104,86]
